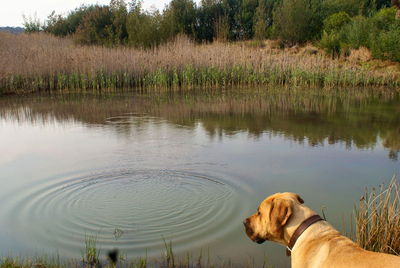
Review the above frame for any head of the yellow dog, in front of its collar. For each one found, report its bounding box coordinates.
[243,193,304,245]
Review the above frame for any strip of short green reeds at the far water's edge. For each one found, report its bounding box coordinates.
[0,64,400,92]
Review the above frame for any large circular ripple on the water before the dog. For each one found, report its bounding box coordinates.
[2,170,238,258]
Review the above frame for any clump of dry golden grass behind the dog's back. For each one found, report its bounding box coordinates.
[353,174,400,255]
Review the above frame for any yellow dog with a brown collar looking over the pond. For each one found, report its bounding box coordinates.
[243,193,400,268]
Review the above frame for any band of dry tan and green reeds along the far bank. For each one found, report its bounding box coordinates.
[0,33,400,93]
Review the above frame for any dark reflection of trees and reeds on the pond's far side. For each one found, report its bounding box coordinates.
[0,88,400,161]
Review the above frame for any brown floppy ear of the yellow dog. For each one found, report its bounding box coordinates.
[269,199,292,233]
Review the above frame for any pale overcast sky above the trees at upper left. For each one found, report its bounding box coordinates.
[0,0,176,27]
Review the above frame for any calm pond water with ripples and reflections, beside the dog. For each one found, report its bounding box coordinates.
[0,88,400,267]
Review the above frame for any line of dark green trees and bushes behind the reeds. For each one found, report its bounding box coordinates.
[24,0,400,59]
